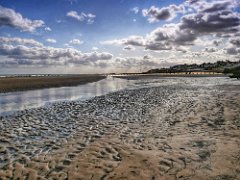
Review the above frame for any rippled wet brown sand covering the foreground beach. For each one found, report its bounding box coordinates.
[0,78,240,180]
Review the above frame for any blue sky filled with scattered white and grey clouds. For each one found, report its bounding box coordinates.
[0,0,240,74]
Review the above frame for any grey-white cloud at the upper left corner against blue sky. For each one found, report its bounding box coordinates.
[0,6,44,32]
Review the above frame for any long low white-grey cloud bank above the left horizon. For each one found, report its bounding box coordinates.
[0,41,113,66]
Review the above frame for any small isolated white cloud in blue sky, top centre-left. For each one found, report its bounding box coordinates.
[66,11,96,24]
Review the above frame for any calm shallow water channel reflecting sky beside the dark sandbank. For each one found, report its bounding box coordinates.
[0,77,133,115]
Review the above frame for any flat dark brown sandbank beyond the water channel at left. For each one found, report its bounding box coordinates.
[0,75,105,93]
